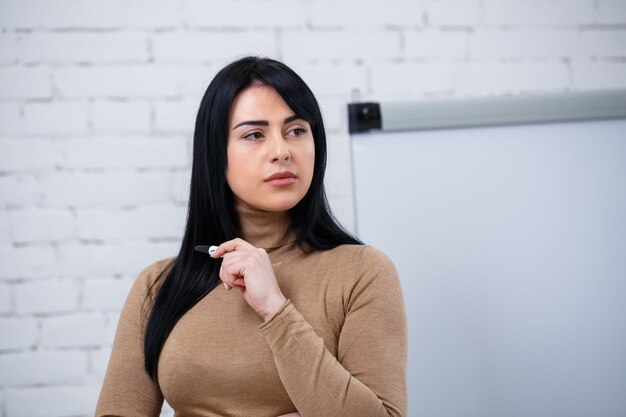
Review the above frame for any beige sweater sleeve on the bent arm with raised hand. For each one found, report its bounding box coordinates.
[260,247,407,417]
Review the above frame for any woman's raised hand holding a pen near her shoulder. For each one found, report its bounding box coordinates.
[212,238,291,320]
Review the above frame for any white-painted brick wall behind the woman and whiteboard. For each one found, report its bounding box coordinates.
[0,0,626,417]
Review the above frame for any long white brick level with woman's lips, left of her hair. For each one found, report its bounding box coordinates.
[43,170,170,206]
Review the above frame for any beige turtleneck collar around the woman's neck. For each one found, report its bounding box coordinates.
[235,202,297,262]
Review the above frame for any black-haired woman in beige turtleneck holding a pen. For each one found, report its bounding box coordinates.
[96,57,406,417]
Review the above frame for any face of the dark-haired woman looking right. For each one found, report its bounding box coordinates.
[226,85,315,211]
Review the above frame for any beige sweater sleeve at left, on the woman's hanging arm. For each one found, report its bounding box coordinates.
[95,261,166,417]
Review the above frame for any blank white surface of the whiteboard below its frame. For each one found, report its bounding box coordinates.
[351,114,626,417]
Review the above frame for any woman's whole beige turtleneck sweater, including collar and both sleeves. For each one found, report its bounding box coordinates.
[96,210,407,417]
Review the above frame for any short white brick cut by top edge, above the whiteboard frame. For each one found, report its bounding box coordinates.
[424,0,482,27]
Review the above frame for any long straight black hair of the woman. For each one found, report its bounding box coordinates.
[144,57,361,379]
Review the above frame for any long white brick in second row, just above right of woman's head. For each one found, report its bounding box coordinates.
[280,31,401,62]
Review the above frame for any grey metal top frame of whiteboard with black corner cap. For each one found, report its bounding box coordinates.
[348,89,626,134]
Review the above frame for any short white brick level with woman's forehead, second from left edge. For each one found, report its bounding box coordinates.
[20,102,89,135]
